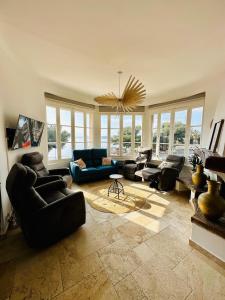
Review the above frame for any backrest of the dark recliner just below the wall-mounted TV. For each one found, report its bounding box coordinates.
[21,152,49,177]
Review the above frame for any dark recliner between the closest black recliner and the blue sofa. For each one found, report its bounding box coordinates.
[21,152,73,188]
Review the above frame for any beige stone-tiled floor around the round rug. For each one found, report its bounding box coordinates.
[0,180,225,300]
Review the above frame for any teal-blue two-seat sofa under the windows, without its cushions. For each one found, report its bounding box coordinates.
[70,149,117,183]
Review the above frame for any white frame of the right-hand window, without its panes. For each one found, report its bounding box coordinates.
[149,98,205,160]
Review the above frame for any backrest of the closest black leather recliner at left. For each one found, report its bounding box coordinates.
[6,163,46,215]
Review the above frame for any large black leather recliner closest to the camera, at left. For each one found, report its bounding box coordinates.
[6,163,86,247]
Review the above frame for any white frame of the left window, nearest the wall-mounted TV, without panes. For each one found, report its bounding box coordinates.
[46,99,94,165]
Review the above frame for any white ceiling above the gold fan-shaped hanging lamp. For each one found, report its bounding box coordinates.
[0,0,225,103]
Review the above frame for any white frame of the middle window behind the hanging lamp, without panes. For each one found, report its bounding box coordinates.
[99,112,144,158]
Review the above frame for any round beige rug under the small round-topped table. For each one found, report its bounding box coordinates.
[85,186,146,214]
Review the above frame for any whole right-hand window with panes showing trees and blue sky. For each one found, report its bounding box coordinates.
[151,105,203,159]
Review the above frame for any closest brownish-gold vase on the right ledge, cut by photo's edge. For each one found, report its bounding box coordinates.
[198,180,225,221]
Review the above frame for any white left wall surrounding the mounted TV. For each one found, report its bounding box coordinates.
[0,45,47,232]
